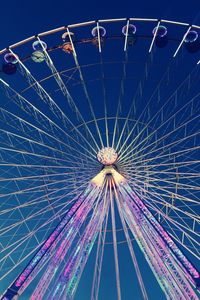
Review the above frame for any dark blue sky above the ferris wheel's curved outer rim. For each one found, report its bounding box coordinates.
[0,0,200,48]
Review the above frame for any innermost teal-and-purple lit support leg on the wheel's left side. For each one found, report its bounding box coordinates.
[45,181,108,299]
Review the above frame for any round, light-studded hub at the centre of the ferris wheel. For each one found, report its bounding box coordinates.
[97,147,118,166]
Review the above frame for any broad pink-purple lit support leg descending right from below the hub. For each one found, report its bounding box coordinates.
[121,187,197,300]
